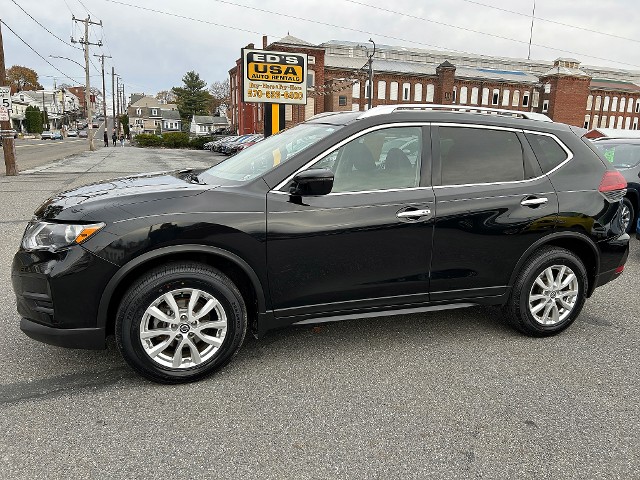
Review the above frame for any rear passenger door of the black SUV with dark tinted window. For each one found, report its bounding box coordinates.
[431,124,558,300]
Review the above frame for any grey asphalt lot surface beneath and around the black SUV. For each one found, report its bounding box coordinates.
[0,147,640,479]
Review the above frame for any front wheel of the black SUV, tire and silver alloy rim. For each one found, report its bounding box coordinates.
[116,262,247,383]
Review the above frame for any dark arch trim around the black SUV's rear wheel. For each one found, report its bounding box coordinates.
[509,232,600,297]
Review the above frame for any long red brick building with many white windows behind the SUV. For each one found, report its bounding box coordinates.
[229,35,640,134]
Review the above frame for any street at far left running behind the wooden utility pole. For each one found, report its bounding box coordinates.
[0,118,113,175]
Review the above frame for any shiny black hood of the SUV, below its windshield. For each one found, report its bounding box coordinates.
[35,170,215,221]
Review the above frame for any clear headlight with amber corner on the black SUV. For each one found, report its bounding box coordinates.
[22,222,105,250]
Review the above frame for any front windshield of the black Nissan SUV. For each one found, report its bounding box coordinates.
[199,123,341,184]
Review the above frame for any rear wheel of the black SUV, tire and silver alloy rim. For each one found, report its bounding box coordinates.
[503,247,587,336]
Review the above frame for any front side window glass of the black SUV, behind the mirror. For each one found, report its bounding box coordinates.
[311,127,422,193]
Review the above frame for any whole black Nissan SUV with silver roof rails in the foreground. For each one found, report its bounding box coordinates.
[12,105,629,383]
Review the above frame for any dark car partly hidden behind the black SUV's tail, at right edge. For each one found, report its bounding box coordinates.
[592,136,640,233]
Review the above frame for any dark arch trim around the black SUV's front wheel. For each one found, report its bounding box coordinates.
[98,245,267,334]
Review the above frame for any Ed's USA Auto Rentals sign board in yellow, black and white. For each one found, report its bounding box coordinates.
[242,48,307,105]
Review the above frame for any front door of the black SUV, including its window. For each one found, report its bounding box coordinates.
[267,126,434,318]
